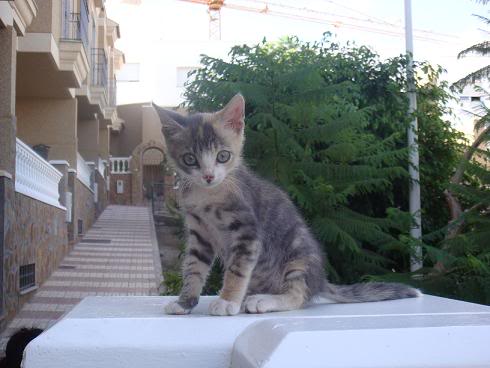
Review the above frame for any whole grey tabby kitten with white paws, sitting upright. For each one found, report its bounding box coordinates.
[155,94,420,316]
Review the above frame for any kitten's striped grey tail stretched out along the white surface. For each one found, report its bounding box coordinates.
[319,282,422,303]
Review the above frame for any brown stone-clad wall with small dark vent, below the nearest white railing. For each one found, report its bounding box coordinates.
[0,178,70,329]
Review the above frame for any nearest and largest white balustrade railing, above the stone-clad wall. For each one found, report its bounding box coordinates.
[15,138,65,209]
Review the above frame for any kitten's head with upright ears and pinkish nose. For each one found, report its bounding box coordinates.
[154,94,245,188]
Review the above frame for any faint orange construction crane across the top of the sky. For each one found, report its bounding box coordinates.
[179,0,457,43]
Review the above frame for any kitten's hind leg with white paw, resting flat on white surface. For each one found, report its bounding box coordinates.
[242,276,308,313]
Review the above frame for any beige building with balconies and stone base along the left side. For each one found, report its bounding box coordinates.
[0,0,124,329]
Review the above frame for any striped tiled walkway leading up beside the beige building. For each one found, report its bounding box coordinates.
[0,206,162,354]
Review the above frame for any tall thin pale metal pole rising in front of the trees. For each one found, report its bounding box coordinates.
[405,0,422,271]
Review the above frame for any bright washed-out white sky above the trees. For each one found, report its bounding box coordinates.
[106,0,490,110]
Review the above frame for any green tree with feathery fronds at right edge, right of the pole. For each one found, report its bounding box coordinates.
[421,0,490,304]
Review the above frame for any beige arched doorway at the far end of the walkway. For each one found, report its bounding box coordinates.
[131,141,174,205]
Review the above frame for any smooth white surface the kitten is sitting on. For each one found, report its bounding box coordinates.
[23,295,490,368]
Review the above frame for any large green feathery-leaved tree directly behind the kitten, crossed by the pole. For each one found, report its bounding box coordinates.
[186,36,460,288]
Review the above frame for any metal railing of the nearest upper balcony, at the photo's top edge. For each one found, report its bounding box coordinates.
[62,0,89,54]
